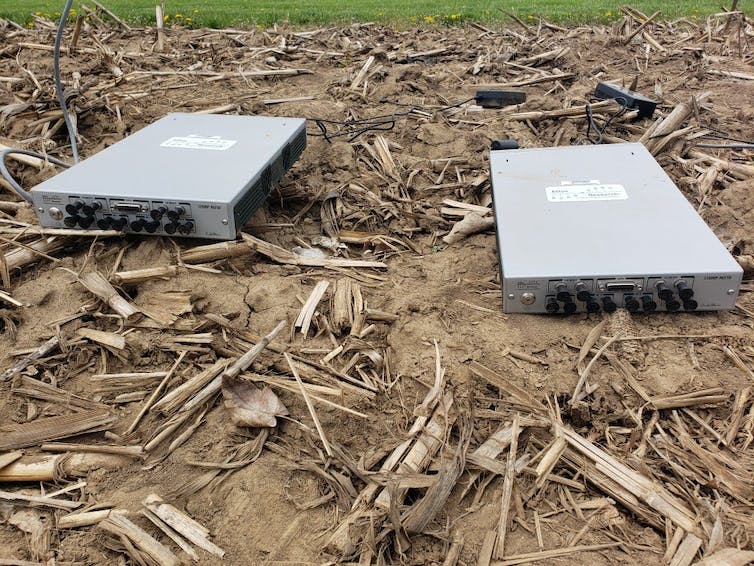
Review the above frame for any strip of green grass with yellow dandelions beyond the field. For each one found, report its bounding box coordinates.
[0,0,752,27]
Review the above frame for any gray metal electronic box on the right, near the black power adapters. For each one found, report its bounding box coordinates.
[490,143,743,314]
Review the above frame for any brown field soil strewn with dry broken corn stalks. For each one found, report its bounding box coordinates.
[0,12,754,564]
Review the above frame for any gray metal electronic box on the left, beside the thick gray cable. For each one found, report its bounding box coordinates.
[31,114,306,240]
